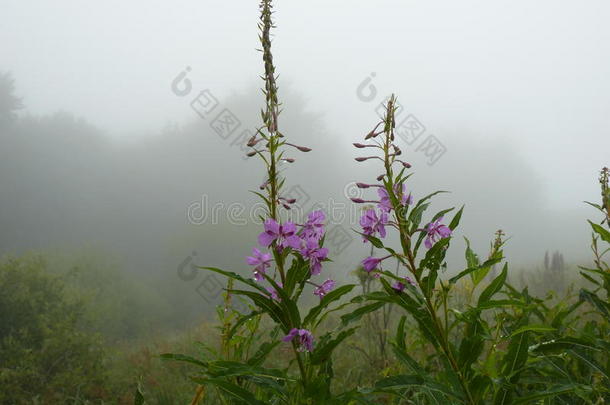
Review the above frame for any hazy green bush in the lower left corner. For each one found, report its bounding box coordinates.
[0,257,105,404]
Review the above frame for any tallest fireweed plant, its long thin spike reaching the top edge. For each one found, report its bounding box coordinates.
[160,0,356,404]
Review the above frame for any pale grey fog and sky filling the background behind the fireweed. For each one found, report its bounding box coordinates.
[0,0,610,322]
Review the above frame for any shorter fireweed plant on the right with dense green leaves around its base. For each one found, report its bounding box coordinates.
[342,95,610,404]
